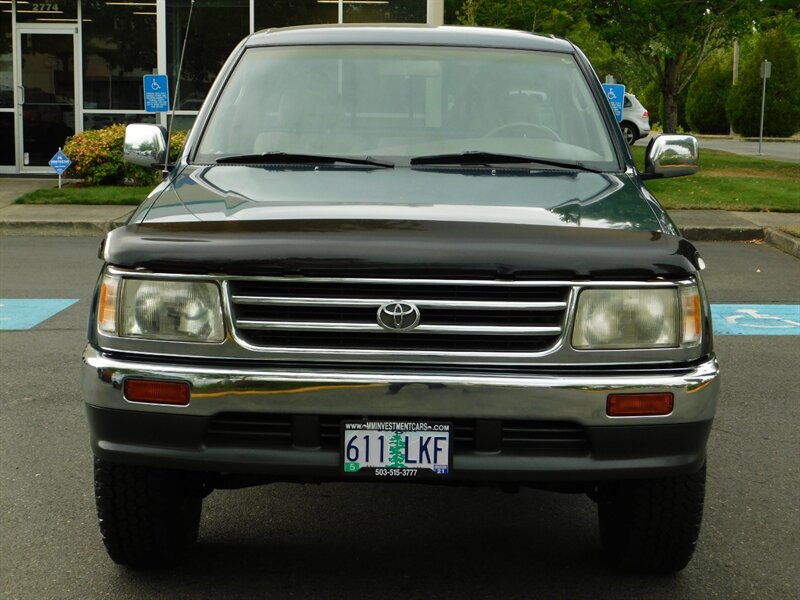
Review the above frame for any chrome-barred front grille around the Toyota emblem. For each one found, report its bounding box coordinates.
[228,278,571,354]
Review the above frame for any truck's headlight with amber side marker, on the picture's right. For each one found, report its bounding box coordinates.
[572,285,700,350]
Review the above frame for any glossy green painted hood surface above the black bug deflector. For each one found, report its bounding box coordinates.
[133,165,665,231]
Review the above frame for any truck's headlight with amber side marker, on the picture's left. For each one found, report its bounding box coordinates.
[98,275,224,342]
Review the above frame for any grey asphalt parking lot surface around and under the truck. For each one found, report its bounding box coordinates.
[0,237,800,599]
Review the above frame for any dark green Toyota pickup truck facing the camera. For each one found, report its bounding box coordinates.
[83,26,719,572]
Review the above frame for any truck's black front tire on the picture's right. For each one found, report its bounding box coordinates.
[596,465,706,573]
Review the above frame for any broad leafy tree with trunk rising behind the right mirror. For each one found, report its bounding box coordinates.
[583,0,761,133]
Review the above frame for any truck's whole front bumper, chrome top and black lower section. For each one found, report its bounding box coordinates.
[83,347,719,483]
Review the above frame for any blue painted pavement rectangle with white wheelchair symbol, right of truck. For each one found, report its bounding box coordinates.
[711,304,800,335]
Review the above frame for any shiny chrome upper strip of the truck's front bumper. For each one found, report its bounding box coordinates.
[83,347,719,427]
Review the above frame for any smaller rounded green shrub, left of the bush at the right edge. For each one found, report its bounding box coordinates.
[686,53,733,133]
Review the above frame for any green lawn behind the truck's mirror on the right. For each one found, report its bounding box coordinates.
[633,146,800,212]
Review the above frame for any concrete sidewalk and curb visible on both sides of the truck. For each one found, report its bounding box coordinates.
[0,178,800,258]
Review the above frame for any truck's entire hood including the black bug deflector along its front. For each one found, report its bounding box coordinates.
[104,166,696,279]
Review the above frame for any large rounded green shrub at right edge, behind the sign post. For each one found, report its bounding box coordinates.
[727,28,800,137]
